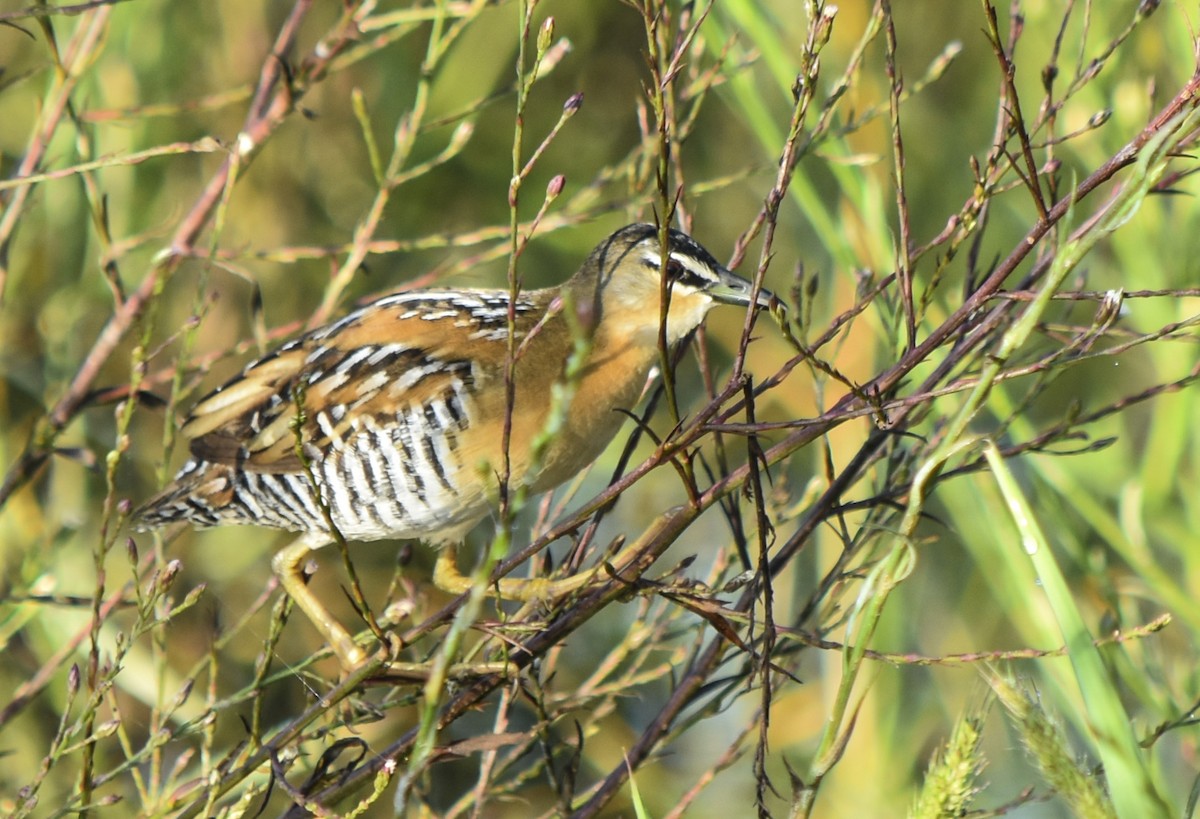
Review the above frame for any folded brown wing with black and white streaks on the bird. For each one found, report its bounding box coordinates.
[182,291,536,473]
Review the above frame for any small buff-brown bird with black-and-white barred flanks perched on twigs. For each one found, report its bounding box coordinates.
[133,223,774,670]
